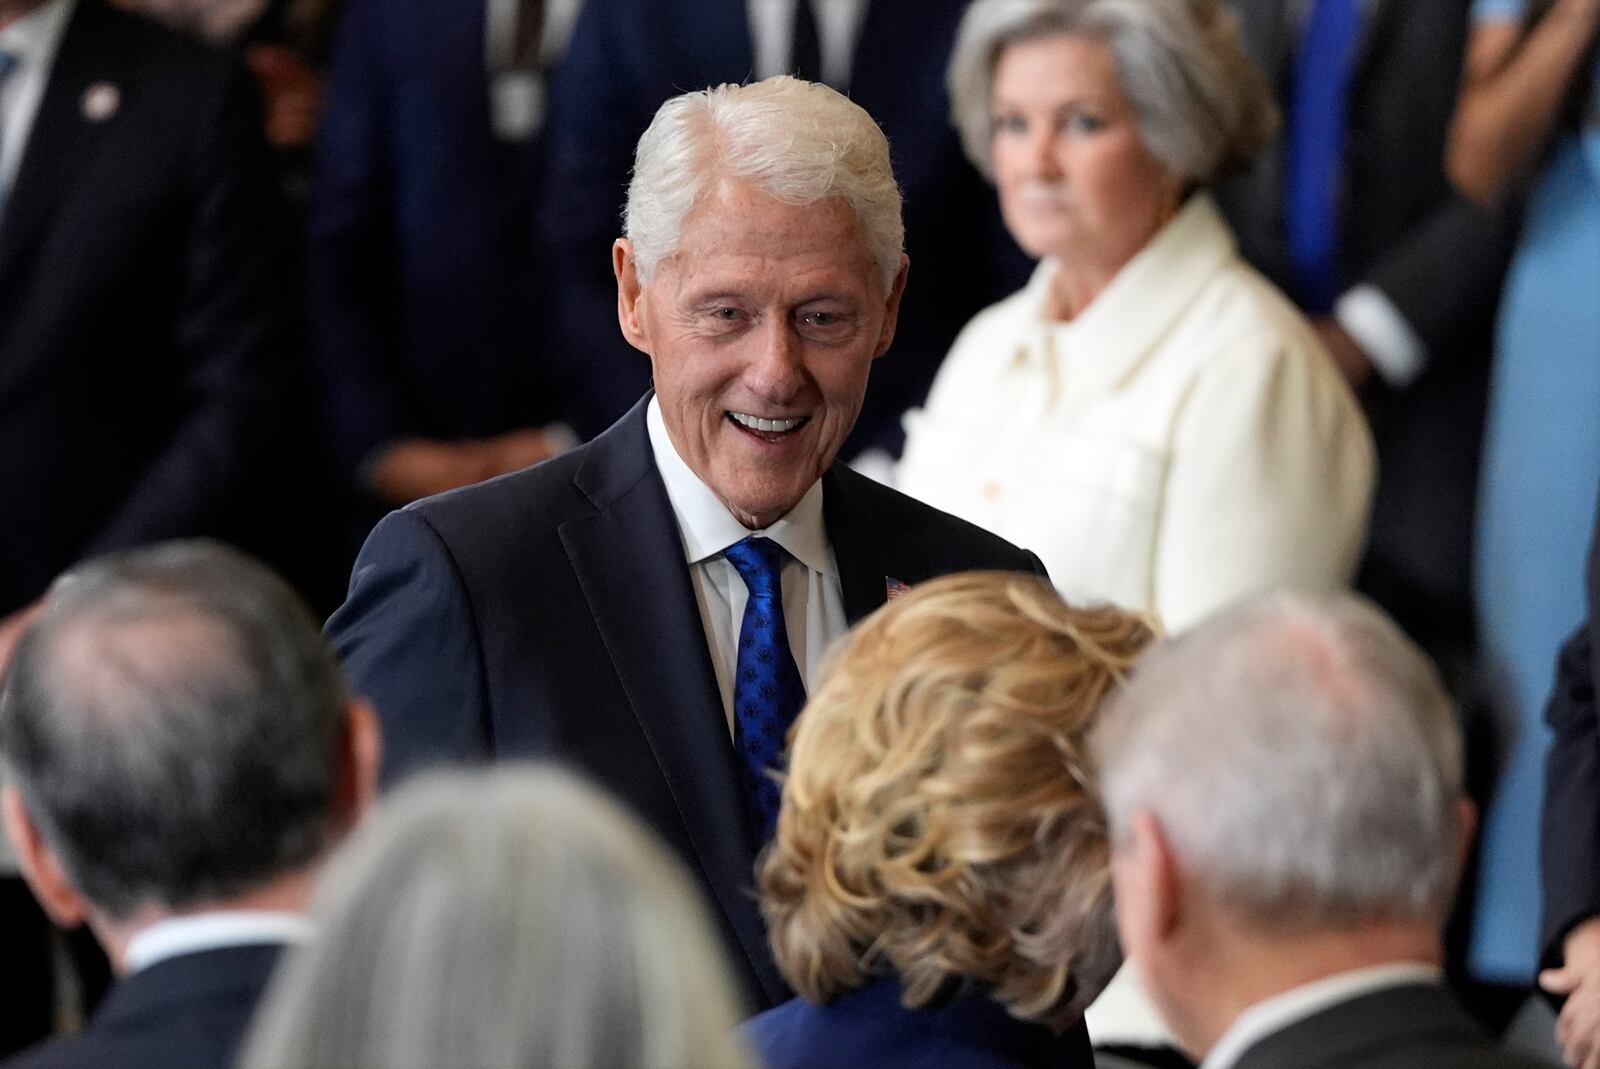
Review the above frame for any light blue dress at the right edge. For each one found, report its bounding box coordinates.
[1469,0,1600,984]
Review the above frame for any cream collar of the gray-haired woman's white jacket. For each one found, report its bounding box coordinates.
[1018,192,1238,384]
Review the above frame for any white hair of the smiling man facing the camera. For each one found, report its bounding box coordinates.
[622,75,906,290]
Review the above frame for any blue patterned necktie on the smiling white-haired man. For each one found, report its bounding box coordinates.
[723,538,805,842]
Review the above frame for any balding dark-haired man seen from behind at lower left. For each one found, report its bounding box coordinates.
[0,543,379,1069]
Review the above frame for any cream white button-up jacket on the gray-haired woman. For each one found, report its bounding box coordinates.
[894,194,1374,631]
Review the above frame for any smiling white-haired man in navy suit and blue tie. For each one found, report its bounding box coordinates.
[328,77,1042,1005]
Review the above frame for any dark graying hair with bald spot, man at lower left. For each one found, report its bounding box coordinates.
[0,541,349,920]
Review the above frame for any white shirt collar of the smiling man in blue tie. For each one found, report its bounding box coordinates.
[645,397,838,576]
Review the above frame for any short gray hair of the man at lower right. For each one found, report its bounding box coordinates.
[1094,594,1464,930]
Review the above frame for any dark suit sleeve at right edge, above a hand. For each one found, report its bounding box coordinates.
[1539,489,1600,967]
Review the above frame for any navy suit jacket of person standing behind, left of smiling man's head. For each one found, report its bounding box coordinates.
[307,0,563,470]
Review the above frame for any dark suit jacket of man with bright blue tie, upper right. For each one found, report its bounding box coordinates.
[1218,0,1512,656]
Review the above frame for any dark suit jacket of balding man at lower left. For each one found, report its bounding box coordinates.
[5,944,282,1069]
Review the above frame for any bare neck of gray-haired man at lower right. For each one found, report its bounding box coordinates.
[1182,922,1443,1055]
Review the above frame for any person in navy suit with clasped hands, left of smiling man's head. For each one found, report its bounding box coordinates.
[306,0,585,551]
